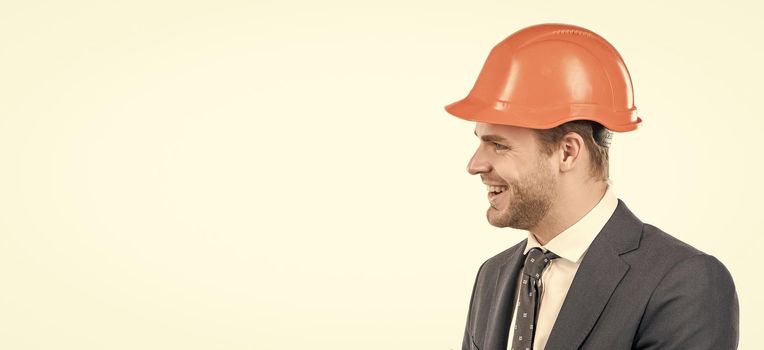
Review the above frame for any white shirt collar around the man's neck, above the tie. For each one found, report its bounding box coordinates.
[523,181,618,263]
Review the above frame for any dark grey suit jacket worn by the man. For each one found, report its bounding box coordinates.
[462,199,739,350]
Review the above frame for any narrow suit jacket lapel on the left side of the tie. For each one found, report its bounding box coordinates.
[480,238,528,350]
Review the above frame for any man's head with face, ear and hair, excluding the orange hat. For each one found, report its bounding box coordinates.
[467,120,610,230]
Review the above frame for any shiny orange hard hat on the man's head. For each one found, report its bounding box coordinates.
[446,23,642,132]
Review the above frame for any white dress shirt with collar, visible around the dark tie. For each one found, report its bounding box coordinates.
[507,182,618,350]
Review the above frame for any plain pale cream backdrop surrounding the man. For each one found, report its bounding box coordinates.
[0,0,764,350]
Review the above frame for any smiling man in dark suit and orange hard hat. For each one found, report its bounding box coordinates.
[446,24,738,350]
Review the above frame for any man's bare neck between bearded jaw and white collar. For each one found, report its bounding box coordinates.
[528,181,608,245]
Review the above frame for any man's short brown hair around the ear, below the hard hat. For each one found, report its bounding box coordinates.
[534,120,613,181]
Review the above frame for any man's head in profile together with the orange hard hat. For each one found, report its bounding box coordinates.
[446,23,642,234]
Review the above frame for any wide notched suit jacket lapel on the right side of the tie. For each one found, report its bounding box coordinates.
[546,199,642,350]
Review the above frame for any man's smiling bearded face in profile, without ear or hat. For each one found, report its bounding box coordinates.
[467,123,558,230]
